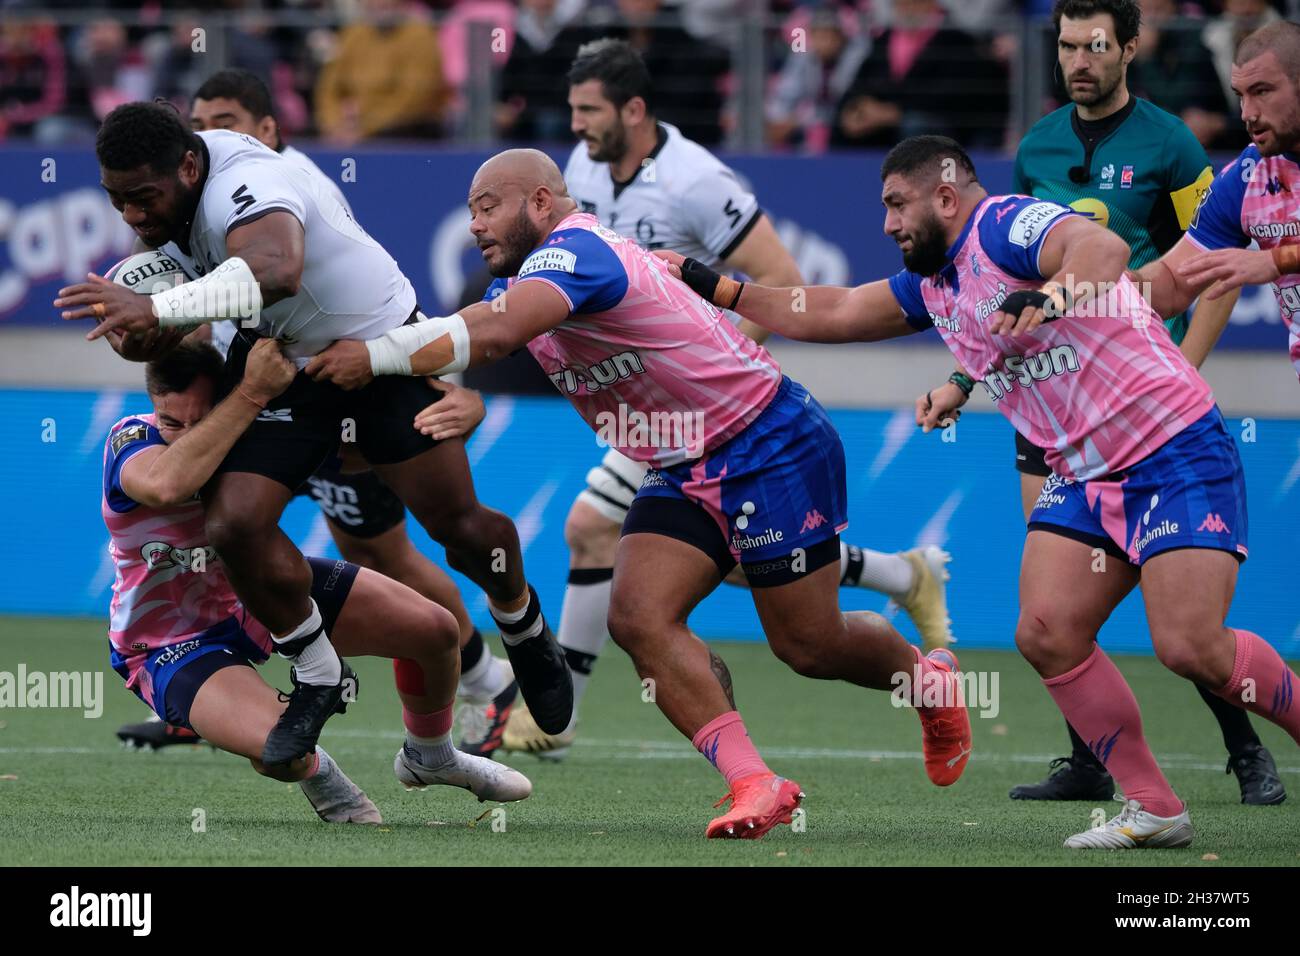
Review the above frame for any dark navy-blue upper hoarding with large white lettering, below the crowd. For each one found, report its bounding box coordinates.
[0,141,1286,350]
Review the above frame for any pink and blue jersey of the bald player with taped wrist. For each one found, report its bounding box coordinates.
[486,213,781,468]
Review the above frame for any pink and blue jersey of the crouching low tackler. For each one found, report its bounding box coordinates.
[101,415,270,700]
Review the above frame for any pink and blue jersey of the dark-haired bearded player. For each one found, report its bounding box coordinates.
[889,196,1214,480]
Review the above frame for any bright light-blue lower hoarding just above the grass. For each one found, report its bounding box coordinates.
[0,389,1300,658]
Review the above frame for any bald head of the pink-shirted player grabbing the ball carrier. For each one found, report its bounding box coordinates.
[469,150,577,278]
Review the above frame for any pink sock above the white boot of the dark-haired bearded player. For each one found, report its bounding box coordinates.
[1043,646,1183,817]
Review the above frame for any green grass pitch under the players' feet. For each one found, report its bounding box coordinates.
[0,618,1300,868]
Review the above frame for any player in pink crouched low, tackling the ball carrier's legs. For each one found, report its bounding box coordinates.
[101,333,532,823]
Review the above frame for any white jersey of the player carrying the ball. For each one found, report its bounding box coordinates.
[172,130,416,368]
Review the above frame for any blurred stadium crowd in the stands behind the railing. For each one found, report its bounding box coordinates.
[0,0,1300,152]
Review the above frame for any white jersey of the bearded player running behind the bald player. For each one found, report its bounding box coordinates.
[564,122,763,268]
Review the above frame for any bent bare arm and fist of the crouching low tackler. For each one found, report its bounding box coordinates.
[122,338,298,507]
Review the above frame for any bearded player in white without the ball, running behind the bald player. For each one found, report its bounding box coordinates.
[503,39,952,758]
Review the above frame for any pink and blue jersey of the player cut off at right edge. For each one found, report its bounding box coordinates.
[1187,143,1300,375]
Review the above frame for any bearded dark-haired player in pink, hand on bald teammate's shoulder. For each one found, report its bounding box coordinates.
[660,130,1300,849]
